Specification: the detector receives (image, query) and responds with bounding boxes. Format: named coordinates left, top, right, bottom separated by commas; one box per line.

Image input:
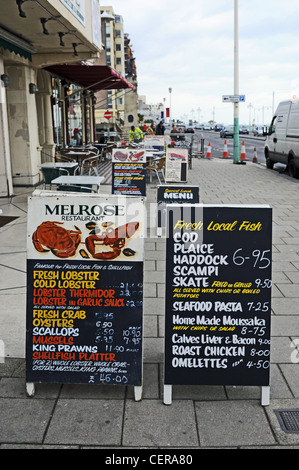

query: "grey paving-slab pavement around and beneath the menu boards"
left=0, top=158, right=299, bottom=454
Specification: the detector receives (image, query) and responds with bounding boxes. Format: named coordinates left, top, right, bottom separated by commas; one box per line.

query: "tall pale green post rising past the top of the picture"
left=234, top=0, right=239, bottom=163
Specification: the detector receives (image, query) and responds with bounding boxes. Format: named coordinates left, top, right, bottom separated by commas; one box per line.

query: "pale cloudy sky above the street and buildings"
left=100, top=0, right=299, bottom=125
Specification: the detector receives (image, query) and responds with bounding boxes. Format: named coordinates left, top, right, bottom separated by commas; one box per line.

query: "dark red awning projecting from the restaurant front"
left=44, top=64, right=136, bottom=92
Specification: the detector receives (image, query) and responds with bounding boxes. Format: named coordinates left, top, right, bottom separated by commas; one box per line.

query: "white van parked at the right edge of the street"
left=265, top=99, right=299, bottom=178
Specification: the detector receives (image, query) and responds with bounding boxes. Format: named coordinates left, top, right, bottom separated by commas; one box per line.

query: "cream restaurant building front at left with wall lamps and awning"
left=0, top=0, right=134, bottom=197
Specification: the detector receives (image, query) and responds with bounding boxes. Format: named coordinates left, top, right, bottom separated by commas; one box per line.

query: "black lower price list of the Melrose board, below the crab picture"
left=26, top=260, right=143, bottom=385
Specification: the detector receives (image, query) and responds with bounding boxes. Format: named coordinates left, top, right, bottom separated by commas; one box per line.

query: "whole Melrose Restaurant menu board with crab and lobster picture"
left=26, top=191, right=145, bottom=386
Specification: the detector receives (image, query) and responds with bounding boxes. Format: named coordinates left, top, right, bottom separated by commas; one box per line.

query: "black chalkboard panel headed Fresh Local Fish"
left=164, top=205, right=272, bottom=386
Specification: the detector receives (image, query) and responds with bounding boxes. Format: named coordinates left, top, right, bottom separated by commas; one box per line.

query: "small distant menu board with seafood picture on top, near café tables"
left=112, top=148, right=146, bottom=196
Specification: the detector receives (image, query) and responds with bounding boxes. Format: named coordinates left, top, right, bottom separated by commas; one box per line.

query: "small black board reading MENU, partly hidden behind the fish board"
left=157, top=184, right=199, bottom=227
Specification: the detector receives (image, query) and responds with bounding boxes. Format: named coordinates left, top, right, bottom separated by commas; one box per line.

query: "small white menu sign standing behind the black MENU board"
left=165, top=148, right=188, bottom=183
